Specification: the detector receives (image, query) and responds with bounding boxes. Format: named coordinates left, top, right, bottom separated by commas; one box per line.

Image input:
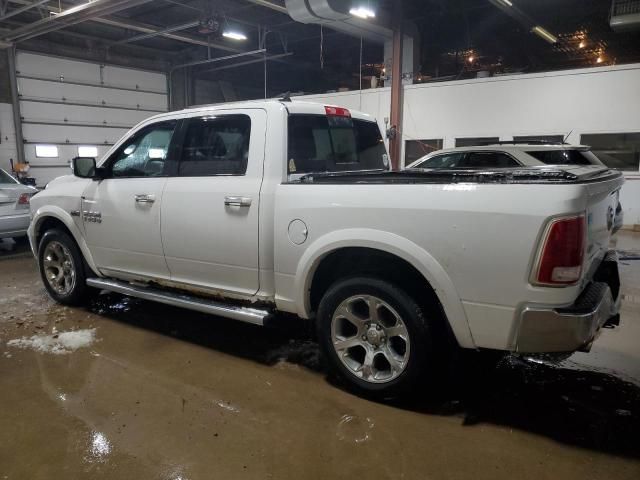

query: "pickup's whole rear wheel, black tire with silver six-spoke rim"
left=317, top=277, right=437, bottom=398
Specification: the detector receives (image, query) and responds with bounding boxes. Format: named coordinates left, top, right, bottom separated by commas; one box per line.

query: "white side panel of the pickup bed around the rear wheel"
left=274, top=180, right=600, bottom=349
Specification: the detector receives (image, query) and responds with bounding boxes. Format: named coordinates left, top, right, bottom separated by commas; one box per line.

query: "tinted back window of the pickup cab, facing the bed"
left=288, top=115, right=388, bottom=174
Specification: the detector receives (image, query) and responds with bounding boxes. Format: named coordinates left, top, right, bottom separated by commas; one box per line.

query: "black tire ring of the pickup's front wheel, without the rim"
left=38, top=229, right=93, bottom=305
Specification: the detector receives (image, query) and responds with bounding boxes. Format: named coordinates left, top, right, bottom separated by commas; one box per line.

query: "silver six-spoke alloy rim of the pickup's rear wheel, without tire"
left=331, top=295, right=410, bottom=383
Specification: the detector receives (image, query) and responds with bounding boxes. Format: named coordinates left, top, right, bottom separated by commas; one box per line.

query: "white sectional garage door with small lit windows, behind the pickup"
left=16, top=52, right=168, bottom=186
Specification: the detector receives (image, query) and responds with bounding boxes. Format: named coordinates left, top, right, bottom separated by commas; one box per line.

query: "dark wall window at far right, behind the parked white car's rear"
left=580, top=132, right=640, bottom=172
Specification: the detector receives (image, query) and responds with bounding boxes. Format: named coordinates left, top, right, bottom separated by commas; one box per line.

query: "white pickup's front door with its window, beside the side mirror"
left=82, top=120, right=178, bottom=279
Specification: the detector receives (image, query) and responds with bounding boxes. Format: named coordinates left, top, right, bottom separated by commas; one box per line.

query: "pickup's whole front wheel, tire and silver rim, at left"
left=38, top=230, right=89, bottom=305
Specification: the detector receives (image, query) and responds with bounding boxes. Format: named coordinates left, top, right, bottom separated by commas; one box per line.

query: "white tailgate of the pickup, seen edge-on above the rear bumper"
left=584, top=170, right=624, bottom=279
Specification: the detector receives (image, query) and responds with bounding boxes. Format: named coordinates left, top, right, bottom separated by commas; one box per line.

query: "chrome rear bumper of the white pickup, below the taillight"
left=516, top=251, right=620, bottom=353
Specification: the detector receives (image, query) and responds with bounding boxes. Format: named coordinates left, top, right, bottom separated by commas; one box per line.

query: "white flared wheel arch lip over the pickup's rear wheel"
left=295, top=229, right=475, bottom=348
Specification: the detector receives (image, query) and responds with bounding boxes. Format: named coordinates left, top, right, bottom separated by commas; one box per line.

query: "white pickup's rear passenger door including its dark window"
left=162, top=109, right=266, bottom=295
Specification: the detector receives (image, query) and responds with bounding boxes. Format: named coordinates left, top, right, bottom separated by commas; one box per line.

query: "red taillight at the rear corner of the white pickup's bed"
left=535, top=215, right=586, bottom=285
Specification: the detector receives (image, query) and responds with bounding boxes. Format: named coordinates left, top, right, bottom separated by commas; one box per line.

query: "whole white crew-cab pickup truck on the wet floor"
left=29, top=101, right=623, bottom=395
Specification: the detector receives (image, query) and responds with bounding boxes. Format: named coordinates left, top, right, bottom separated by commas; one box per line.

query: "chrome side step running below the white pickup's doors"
left=87, top=278, right=270, bottom=327
